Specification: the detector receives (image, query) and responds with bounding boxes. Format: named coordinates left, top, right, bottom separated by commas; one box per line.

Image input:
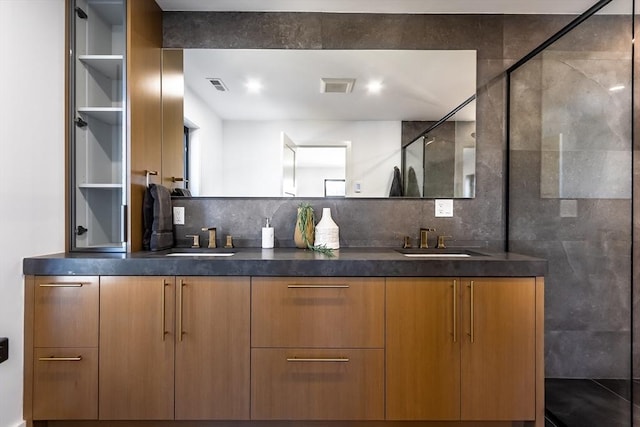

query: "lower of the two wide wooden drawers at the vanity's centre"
left=251, top=348, right=384, bottom=420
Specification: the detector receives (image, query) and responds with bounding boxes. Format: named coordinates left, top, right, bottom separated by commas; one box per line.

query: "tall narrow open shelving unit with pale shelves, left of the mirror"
left=69, top=0, right=127, bottom=251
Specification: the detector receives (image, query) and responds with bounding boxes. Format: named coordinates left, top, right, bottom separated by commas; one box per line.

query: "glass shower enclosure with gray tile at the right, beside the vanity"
left=507, top=0, right=640, bottom=427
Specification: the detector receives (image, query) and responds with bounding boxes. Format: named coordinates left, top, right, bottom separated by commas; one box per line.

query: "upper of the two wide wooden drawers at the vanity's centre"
left=251, top=277, right=384, bottom=348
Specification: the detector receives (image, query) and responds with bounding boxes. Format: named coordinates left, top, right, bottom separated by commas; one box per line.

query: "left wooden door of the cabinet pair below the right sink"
left=386, top=278, right=460, bottom=420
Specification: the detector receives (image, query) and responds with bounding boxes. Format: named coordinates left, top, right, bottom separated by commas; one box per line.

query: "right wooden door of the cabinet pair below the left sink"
left=175, top=277, right=251, bottom=420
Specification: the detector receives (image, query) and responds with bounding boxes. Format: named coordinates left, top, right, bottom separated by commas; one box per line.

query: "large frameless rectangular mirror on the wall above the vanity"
left=184, top=49, right=476, bottom=198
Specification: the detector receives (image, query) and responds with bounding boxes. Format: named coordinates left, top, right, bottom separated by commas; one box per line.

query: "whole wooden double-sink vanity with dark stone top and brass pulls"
left=24, top=248, right=547, bottom=427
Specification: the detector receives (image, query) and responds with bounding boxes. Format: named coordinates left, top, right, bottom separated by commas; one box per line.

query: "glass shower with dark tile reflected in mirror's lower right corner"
left=402, top=95, right=476, bottom=198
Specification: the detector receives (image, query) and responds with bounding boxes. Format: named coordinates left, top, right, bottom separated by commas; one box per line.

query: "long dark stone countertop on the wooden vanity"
left=23, top=248, right=547, bottom=277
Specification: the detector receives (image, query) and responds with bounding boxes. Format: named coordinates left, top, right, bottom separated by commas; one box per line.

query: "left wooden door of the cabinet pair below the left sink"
left=99, top=276, right=175, bottom=420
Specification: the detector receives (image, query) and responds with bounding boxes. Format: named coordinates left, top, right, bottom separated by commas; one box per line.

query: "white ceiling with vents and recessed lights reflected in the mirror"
left=184, top=49, right=476, bottom=121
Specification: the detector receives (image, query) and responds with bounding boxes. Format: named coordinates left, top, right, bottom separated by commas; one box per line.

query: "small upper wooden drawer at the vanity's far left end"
left=33, top=276, right=100, bottom=347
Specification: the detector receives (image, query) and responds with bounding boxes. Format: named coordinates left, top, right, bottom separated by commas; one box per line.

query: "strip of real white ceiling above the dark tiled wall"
left=156, top=0, right=630, bottom=14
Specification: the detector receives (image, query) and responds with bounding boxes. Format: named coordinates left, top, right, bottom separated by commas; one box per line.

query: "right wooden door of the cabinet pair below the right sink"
left=461, top=278, right=536, bottom=420
